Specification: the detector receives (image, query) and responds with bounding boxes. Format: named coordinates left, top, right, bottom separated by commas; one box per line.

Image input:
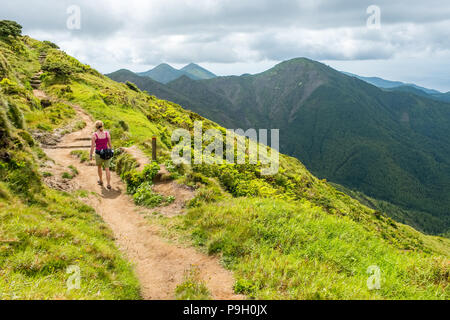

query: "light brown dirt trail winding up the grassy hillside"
left=44, top=105, right=244, bottom=300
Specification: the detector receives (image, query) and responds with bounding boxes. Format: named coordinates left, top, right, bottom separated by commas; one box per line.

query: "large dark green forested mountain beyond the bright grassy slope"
left=112, top=59, right=450, bottom=234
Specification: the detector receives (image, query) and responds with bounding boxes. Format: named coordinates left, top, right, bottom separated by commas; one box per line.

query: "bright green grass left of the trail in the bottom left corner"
left=0, top=190, right=140, bottom=300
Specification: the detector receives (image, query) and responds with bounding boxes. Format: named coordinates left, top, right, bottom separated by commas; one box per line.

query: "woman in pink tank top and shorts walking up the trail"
left=90, top=121, right=112, bottom=190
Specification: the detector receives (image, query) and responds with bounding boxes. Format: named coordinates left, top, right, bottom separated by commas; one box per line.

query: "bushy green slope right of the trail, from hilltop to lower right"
left=0, top=28, right=450, bottom=299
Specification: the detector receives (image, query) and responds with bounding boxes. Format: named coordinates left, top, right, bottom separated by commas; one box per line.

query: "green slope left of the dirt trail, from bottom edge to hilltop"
left=0, top=33, right=140, bottom=300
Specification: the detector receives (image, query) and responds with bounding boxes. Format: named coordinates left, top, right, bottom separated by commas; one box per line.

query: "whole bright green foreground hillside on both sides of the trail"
left=0, top=26, right=450, bottom=300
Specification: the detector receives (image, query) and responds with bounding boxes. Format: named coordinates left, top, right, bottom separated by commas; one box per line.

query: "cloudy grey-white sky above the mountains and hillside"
left=0, top=0, right=450, bottom=91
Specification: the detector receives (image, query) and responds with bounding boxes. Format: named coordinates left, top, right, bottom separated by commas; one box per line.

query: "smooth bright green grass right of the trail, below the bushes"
left=171, top=198, right=450, bottom=299
